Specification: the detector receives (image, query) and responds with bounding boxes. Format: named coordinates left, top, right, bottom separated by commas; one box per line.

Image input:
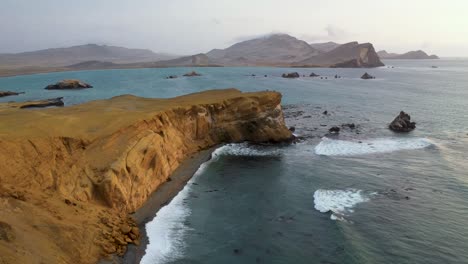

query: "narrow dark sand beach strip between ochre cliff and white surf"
left=99, top=146, right=218, bottom=264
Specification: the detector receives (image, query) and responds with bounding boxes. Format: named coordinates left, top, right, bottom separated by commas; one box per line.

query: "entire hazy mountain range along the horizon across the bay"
left=0, top=34, right=438, bottom=76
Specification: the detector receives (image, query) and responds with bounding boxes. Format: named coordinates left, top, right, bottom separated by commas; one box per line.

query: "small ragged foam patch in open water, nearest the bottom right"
left=314, top=189, right=372, bottom=221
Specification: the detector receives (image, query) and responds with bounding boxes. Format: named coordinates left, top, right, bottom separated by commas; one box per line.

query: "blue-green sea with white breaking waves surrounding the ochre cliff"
left=0, top=60, right=468, bottom=264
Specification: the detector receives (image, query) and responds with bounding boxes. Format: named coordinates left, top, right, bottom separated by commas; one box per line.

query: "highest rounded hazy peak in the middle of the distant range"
left=206, top=34, right=320, bottom=66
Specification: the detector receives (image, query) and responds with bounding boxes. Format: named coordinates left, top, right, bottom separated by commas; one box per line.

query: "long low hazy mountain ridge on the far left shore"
left=0, top=44, right=175, bottom=68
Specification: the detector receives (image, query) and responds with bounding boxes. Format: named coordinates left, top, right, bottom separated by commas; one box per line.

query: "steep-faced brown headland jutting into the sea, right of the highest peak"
left=295, top=42, right=384, bottom=68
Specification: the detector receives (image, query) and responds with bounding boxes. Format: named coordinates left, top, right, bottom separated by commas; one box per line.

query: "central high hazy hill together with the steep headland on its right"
left=156, top=34, right=383, bottom=67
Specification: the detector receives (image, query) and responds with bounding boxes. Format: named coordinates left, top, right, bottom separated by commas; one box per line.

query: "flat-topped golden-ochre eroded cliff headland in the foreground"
left=0, top=89, right=291, bottom=264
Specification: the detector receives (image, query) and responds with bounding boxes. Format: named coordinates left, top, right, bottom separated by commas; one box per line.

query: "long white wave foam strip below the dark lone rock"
left=315, top=137, right=433, bottom=156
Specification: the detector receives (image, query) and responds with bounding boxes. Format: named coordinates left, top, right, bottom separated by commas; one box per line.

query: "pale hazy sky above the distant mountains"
left=0, top=0, right=468, bottom=57
